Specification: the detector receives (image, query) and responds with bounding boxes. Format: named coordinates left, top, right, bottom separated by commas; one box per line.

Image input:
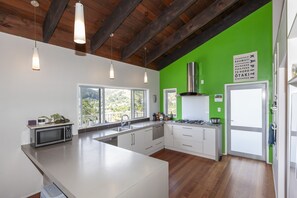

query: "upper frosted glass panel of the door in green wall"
left=231, top=89, right=262, bottom=128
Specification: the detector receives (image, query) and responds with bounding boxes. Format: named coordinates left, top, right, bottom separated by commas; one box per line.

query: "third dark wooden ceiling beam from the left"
left=122, top=0, right=197, bottom=60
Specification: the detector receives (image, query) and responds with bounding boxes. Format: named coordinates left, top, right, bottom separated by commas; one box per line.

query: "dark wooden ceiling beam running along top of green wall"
left=157, top=0, right=271, bottom=70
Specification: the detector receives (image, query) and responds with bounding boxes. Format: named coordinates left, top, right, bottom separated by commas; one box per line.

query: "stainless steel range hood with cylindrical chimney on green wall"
left=179, top=62, right=205, bottom=96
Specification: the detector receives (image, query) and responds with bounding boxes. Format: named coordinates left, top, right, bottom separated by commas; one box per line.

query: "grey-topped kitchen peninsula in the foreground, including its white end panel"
left=22, top=122, right=168, bottom=198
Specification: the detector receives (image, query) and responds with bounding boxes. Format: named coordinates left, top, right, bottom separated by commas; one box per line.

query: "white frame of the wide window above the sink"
left=77, top=84, right=150, bottom=129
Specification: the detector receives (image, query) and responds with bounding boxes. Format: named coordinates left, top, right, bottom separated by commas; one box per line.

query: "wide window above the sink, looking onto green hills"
left=78, top=85, right=147, bottom=127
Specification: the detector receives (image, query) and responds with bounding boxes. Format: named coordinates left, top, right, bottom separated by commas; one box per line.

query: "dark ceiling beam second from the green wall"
left=147, top=0, right=239, bottom=64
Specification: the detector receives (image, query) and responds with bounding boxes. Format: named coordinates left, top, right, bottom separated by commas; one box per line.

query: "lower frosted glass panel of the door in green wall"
left=231, top=130, right=262, bottom=156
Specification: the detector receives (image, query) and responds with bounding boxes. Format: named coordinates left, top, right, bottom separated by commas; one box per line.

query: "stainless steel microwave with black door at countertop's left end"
left=30, top=124, right=72, bottom=147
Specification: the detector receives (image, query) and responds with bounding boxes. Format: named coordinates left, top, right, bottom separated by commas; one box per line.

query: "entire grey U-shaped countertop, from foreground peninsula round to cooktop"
left=22, top=121, right=217, bottom=198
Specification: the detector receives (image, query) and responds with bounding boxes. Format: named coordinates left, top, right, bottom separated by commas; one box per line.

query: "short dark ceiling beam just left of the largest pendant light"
left=43, top=0, right=69, bottom=43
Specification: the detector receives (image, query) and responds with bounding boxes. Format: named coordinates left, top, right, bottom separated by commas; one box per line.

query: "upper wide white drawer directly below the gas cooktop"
left=173, top=126, right=203, bottom=141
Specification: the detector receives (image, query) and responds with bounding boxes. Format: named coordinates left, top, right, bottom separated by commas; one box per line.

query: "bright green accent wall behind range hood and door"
left=160, top=3, right=272, bottom=162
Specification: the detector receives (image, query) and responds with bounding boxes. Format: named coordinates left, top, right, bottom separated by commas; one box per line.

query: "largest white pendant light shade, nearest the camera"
left=74, top=1, right=86, bottom=44
